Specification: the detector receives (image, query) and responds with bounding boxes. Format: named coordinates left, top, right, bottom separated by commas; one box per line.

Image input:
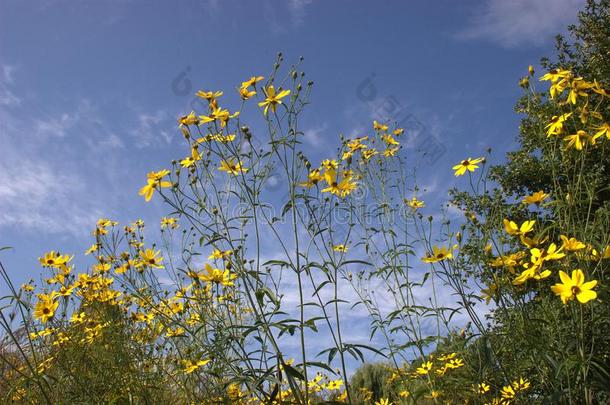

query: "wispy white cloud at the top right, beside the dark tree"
left=457, top=0, right=584, bottom=47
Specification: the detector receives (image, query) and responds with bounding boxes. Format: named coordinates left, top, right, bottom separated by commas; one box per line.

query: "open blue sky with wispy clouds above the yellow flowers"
left=0, top=0, right=583, bottom=364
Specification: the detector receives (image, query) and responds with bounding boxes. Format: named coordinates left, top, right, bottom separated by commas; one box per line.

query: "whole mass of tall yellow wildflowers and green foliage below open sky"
left=0, top=0, right=610, bottom=405
